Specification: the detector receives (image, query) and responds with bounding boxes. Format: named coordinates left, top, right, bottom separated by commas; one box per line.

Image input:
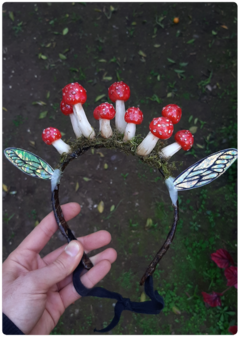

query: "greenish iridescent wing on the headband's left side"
left=4, top=147, right=54, bottom=180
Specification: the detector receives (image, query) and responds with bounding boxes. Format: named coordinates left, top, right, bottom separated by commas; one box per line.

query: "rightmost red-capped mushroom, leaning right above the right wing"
left=159, top=130, right=194, bottom=158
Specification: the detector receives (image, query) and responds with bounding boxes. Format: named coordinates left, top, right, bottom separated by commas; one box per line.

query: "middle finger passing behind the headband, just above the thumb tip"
left=43, top=230, right=112, bottom=265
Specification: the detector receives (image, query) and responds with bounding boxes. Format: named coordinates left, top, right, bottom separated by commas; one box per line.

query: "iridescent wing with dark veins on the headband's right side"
left=173, top=149, right=239, bottom=191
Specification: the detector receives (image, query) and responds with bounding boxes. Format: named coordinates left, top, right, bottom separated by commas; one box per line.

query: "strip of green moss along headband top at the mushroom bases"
left=59, top=130, right=175, bottom=179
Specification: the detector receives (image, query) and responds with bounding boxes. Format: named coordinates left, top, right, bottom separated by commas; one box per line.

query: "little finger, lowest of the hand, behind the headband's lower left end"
left=60, top=260, right=111, bottom=308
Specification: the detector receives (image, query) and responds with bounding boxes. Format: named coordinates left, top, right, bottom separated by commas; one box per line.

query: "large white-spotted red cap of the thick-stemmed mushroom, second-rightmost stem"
left=149, top=117, right=173, bottom=139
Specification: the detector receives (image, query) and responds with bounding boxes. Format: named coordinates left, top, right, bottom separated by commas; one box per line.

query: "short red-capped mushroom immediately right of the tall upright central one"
left=123, top=107, right=143, bottom=142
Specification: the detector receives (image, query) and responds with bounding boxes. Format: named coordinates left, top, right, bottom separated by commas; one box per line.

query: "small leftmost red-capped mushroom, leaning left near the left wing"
left=42, top=127, right=71, bottom=154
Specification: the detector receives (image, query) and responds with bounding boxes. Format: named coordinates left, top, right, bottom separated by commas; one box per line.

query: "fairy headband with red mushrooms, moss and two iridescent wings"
left=4, top=82, right=239, bottom=330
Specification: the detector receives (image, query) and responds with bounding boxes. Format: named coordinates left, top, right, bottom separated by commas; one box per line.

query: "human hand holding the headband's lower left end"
left=0, top=203, right=117, bottom=336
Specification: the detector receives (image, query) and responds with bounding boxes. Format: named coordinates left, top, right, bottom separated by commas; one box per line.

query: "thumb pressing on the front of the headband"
left=31, top=240, right=83, bottom=290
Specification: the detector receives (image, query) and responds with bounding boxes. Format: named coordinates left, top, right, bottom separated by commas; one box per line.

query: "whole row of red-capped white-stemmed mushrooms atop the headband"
left=42, top=81, right=194, bottom=159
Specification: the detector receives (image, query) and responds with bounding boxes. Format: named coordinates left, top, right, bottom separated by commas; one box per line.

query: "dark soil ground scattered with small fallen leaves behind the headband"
left=0, top=1, right=239, bottom=335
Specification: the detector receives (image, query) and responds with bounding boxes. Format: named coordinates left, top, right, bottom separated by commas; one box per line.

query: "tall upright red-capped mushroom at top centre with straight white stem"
left=108, top=81, right=130, bottom=133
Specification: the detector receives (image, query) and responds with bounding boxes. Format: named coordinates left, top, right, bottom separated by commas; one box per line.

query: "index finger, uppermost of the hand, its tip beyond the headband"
left=17, top=202, right=81, bottom=254
